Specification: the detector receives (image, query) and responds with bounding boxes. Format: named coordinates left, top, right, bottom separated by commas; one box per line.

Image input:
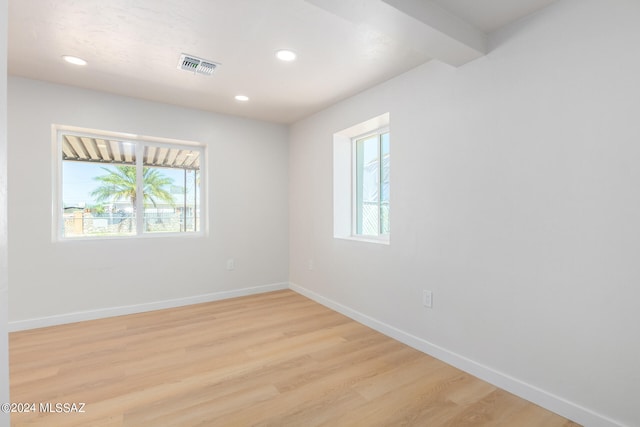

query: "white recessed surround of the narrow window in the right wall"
left=333, top=113, right=392, bottom=245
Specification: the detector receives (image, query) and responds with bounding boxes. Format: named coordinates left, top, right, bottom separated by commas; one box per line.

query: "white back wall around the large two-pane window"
left=8, top=76, right=288, bottom=329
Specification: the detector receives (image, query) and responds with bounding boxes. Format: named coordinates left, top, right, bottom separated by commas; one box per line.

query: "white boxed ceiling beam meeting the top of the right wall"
left=306, top=0, right=487, bottom=67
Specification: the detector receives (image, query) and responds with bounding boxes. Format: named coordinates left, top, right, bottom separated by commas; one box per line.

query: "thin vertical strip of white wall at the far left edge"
left=0, top=0, right=9, bottom=427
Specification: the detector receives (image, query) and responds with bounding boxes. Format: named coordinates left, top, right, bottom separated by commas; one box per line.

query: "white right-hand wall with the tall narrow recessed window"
left=289, top=0, right=640, bottom=426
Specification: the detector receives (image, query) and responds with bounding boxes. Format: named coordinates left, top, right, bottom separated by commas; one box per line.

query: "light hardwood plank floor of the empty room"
left=9, top=291, right=577, bottom=427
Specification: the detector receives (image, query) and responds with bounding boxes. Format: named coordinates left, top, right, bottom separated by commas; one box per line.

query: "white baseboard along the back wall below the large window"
left=9, top=283, right=289, bottom=332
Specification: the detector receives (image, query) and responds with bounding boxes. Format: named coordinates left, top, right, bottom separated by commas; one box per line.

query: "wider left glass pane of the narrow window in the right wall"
left=356, top=135, right=380, bottom=236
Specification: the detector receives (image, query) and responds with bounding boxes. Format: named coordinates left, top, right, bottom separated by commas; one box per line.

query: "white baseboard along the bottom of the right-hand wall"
left=289, top=283, right=624, bottom=427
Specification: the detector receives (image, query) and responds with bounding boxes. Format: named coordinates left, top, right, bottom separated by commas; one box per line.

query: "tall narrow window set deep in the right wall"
left=353, top=130, right=391, bottom=237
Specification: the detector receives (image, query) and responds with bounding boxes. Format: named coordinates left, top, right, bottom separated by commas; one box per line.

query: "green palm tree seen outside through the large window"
left=91, top=166, right=175, bottom=212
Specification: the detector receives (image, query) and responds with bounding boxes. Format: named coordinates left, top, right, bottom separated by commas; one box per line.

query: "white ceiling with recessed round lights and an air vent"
left=8, top=0, right=554, bottom=123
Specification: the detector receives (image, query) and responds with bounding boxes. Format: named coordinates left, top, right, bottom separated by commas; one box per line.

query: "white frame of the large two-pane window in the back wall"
left=51, top=124, right=208, bottom=242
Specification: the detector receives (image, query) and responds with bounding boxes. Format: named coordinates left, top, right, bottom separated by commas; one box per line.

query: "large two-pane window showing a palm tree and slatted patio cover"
left=54, top=127, right=204, bottom=239
